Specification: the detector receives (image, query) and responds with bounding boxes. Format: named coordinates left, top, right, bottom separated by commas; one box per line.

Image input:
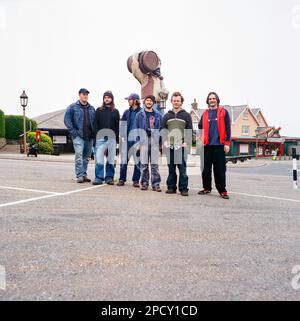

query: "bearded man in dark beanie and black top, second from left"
left=93, top=91, right=120, bottom=185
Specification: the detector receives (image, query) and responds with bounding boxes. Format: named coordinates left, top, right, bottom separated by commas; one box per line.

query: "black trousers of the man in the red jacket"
left=202, top=145, right=226, bottom=193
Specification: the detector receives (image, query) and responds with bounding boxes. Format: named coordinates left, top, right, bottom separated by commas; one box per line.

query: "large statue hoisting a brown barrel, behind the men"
left=127, top=51, right=169, bottom=109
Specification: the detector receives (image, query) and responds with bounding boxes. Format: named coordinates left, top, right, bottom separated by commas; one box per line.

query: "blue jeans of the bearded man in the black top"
left=95, top=138, right=117, bottom=182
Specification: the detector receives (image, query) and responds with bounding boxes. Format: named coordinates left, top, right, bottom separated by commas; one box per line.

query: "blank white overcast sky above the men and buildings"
left=0, top=0, right=300, bottom=136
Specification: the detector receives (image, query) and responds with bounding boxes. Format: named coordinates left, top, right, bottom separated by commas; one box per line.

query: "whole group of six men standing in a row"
left=64, top=88, right=230, bottom=198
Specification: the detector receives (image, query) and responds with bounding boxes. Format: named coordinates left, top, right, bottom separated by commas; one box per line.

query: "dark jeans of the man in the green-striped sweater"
left=167, top=148, right=189, bottom=192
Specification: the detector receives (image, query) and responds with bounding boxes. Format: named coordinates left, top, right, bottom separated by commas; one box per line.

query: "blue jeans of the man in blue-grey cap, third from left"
left=120, top=142, right=141, bottom=182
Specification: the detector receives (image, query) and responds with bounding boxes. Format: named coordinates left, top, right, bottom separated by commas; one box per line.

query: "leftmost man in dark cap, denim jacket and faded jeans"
left=64, top=88, right=95, bottom=183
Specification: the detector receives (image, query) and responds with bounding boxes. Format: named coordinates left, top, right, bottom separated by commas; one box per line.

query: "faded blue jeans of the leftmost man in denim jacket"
left=73, top=136, right=93, bottom=178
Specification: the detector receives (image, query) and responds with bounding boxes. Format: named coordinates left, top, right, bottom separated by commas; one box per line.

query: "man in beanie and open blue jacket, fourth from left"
left=136, top=95, right=162, bottom=192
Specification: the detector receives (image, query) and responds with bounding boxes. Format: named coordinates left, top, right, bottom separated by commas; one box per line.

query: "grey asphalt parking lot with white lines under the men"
left=0, top=159, right=300, bottom=300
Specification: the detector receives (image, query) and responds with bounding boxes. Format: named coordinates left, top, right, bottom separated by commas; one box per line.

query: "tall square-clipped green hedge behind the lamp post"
left=5, top=115, right=37, bottom=139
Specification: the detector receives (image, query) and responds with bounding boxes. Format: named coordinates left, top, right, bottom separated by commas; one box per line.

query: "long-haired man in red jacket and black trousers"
left=198, top=92, right=231, bottom=199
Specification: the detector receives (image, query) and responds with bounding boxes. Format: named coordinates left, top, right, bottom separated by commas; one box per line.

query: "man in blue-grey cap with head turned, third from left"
left=117, top=93, right=142, bottom=187
